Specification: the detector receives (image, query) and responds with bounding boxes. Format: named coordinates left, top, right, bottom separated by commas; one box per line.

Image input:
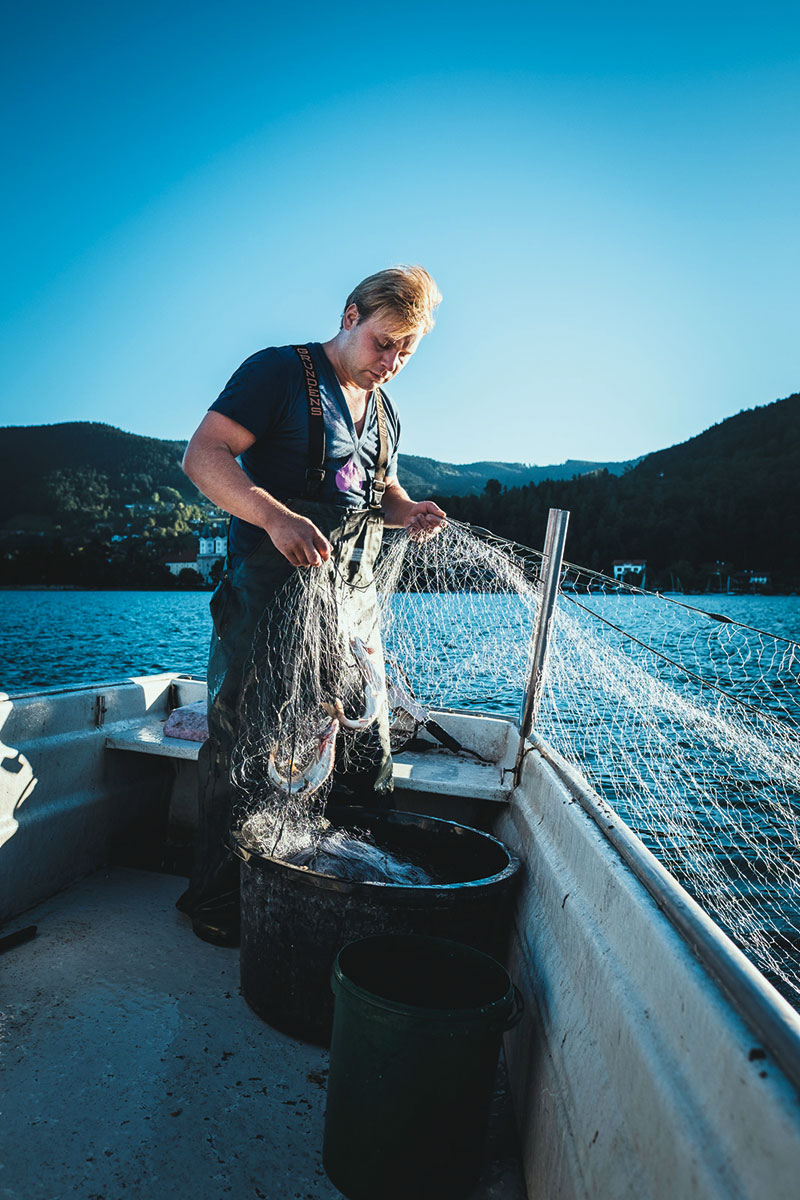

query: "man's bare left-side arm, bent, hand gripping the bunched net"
left=184, top=413, right=331, bottom=566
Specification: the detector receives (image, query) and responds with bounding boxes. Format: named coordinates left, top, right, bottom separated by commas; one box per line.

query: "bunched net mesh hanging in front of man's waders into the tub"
left=231, top=544, right=383, bottom=860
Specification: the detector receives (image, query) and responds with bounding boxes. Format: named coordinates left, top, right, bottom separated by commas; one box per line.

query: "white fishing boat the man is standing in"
left=0, top=673, right=800, bottom=1200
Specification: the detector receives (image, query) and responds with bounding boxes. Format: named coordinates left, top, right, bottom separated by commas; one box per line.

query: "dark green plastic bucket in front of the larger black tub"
left=323, top=935, right=519, bottom=1200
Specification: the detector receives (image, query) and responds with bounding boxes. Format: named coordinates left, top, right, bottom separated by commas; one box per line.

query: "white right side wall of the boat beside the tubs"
left=497, top=751, right=800, bottom=1200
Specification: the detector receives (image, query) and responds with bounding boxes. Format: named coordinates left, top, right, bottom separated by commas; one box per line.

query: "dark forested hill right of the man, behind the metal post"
left=443, top=394, right=800, bottom=588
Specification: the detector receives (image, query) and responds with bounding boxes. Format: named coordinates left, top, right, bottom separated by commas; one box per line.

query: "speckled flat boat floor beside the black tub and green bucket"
left=0, top=869, right=525, bottom=1200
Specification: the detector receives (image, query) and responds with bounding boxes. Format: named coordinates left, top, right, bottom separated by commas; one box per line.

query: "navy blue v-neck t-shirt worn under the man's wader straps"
left=210, top=342, right=399, bottom=559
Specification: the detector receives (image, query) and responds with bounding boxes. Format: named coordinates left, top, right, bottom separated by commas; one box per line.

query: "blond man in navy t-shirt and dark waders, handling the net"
left=179, top=266, right=445, bottom=944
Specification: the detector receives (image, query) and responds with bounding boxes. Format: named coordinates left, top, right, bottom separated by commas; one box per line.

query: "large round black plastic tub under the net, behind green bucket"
left=233, top=808, right=519, bottom=1045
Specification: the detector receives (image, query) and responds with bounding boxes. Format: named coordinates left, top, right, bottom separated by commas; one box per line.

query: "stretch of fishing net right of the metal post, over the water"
left=537, top=566, right=800, bottom=1003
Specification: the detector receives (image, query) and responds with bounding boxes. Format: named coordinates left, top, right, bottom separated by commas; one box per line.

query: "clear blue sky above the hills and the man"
left=0, top=0, right=800, bottom=463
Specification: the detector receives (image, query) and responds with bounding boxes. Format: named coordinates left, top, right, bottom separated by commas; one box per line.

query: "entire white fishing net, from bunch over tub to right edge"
left=226, top=522, right=800, bottom=1002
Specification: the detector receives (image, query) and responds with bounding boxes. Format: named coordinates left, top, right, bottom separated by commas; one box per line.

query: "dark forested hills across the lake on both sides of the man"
left=0, top=395, right=800, bottom=590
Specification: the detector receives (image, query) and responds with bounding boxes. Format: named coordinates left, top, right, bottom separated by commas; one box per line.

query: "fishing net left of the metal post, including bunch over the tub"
left=231, top=524, right=537, bottom=877
